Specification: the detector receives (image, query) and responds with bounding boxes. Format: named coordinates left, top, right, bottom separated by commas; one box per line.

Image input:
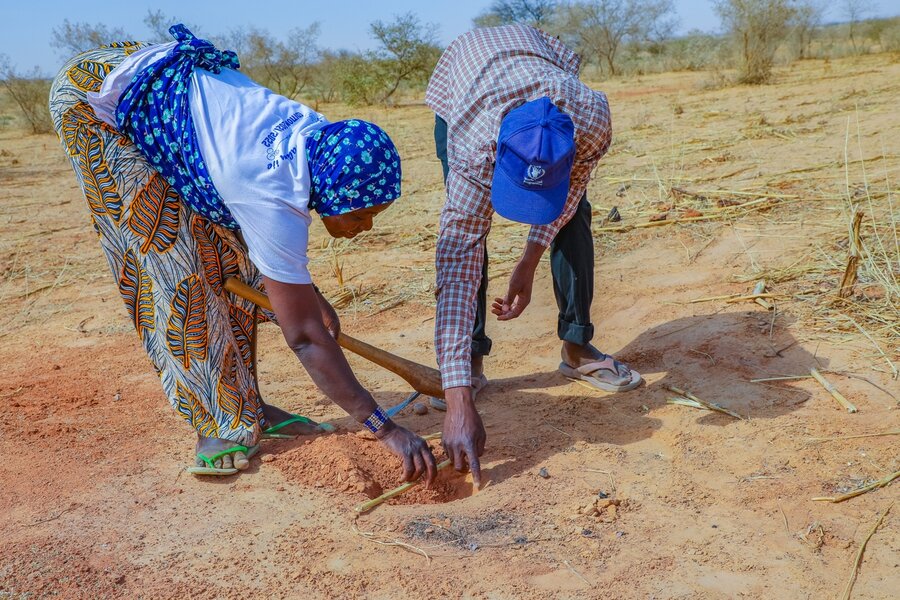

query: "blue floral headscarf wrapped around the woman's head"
left=306, top=119, right=400, bottom=217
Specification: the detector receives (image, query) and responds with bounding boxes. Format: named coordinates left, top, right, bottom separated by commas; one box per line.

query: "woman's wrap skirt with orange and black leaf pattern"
left=50, top=42, right=267, bottom=446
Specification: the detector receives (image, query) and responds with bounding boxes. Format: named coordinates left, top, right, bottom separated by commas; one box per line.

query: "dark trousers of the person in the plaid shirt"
left=434, top=115, right=594, bottom=356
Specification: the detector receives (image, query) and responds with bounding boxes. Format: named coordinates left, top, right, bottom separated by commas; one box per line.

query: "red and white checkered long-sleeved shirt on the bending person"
left=425, top=25, right=612, bottom=389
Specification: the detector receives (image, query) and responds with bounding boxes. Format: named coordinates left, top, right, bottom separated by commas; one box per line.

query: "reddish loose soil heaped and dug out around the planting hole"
left=273, top=433, right=471, bottom=504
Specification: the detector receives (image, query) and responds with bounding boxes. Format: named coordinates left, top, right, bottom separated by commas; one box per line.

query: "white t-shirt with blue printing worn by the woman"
left=88, top=42, right=328, bottom=283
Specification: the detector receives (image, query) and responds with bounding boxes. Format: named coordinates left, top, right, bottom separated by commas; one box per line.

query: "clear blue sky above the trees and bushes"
left=0, top=0, right=900, bottom=74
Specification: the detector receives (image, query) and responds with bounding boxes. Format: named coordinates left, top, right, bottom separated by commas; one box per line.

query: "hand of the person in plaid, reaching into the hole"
left=441, top=386, right=487, bottom=489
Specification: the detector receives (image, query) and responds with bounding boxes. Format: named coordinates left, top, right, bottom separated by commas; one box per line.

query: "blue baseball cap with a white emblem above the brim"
left=491, top=98, right=575, bottom=225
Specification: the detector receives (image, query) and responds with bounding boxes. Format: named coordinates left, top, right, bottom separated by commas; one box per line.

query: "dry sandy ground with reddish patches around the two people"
left=0, top=56, right=900, bottom=599
